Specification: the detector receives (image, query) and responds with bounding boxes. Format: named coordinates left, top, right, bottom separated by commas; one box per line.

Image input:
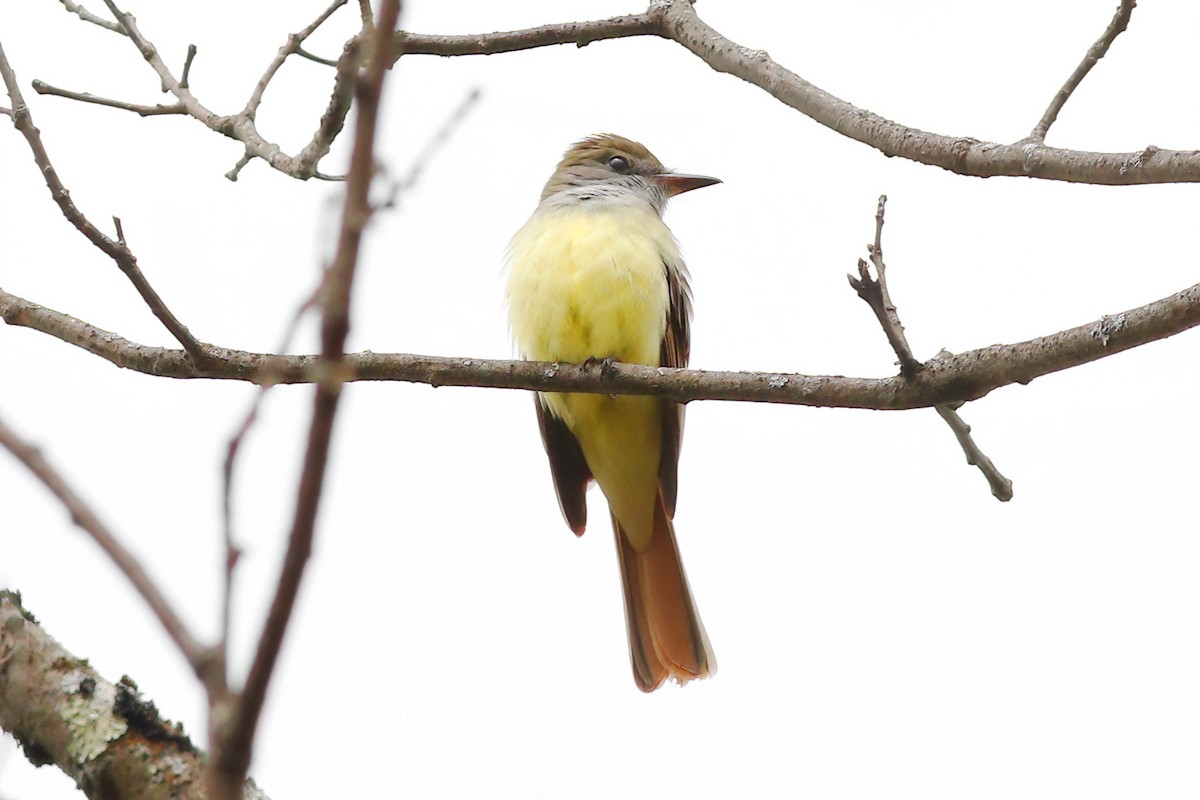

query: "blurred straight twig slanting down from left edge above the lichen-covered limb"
left=0, top=421, right=212, bottom=685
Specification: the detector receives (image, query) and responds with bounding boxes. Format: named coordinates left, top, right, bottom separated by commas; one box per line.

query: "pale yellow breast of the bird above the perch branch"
left=508, top=205, right=679, bottom=365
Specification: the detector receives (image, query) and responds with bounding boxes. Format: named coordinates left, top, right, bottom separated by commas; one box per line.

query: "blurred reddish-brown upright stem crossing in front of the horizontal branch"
left=210, top=0, right=400, bottom=798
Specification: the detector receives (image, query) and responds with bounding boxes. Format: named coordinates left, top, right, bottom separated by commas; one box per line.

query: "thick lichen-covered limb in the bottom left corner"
left=0, top=590, right=265, bottom=800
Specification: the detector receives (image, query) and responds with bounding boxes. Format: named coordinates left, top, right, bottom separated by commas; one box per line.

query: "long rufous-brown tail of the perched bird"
left=612, top=495, right=716, bottom=692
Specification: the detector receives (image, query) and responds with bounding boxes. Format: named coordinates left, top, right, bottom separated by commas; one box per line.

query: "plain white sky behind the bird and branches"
left=0, top=0, right=1200, bottom=800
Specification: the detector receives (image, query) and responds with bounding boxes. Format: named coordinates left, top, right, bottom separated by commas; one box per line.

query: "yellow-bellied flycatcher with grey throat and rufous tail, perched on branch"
left=508, top=134, right=720, bottom=692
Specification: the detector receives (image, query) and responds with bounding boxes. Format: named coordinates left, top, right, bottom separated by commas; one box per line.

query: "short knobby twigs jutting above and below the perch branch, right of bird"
left=846, top=196, right=1013, bottom=503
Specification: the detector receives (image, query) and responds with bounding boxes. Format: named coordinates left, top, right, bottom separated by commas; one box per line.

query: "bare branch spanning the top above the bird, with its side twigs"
left=37, top=0, right=1200, bottom=186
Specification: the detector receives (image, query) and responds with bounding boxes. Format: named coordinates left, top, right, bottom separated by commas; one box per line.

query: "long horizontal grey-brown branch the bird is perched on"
left=0, top=283, right=1200, bottom=410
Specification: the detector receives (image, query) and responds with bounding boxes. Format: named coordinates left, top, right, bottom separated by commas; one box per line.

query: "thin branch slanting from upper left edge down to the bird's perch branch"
left=0, top=47, right=208, bottom=365
